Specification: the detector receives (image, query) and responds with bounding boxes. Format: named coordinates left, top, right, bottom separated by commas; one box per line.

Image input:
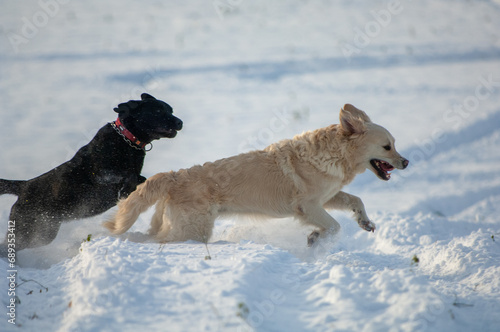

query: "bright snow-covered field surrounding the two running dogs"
left=0, top=0, right=500, bottom=331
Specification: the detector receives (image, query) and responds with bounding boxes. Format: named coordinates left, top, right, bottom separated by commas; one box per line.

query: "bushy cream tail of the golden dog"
left=103, top=172, right=175, bottom=234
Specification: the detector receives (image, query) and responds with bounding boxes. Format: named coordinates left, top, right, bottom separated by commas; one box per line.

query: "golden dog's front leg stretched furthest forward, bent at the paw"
left=324, top=191, right=376, bottom=232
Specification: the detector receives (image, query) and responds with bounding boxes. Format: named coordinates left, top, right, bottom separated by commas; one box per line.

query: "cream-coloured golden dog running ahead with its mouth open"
left=105, top=104, right=408, bottom=245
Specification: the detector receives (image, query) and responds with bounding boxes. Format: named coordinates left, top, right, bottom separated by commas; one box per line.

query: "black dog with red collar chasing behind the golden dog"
left=0, top=93, right=182, bottom=256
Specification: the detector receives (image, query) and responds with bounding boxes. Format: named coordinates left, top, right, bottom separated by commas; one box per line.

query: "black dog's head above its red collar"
left=114, top=93, right=182, bottom=142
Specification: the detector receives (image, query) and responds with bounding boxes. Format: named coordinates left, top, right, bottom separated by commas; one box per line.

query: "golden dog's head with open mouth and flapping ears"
left=340, top=104, right=409, bottom=181
